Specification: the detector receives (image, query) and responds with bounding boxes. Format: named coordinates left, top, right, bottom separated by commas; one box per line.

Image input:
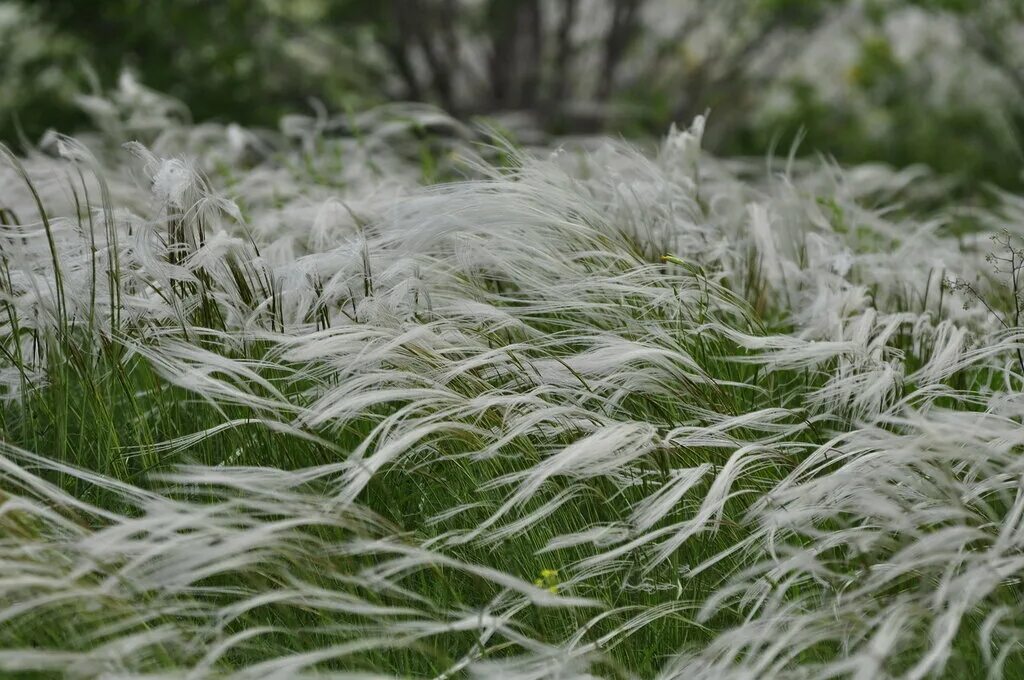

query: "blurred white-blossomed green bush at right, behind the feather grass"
left=751, top=0, right=1024, bottom=186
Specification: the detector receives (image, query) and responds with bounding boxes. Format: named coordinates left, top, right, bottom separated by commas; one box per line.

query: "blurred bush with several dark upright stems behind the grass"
left=315, top=0, right=643, bottom=126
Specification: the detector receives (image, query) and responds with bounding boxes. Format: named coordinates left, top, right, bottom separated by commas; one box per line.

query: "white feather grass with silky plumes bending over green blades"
left=0, top=86, right=1024, bottom=680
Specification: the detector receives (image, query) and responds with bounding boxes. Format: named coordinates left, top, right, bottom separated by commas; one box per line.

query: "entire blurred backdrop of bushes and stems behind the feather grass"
left=0, top=0, right=1024, bottom=196
